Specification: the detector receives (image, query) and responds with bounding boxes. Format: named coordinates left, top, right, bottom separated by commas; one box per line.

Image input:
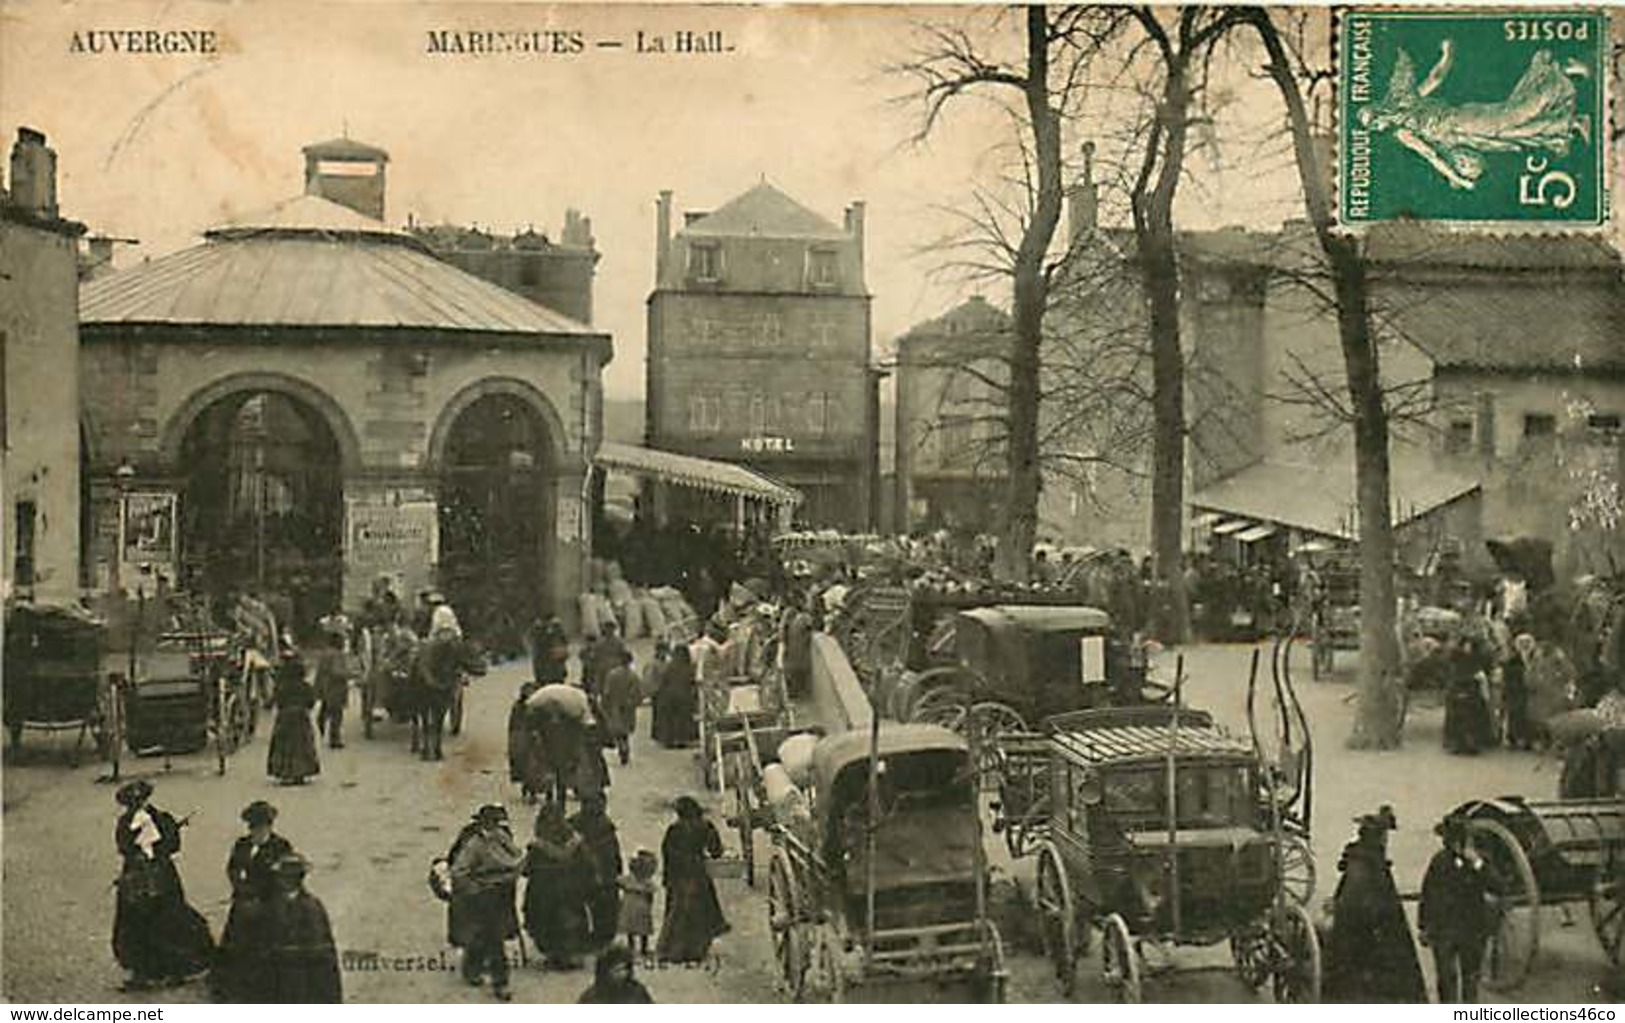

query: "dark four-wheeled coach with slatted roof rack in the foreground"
left=1037, top=706, right=1321, bottom=1002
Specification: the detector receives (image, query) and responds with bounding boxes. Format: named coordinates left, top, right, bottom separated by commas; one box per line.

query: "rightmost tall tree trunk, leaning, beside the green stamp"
left=1248, top=8, right=1404, bottom=749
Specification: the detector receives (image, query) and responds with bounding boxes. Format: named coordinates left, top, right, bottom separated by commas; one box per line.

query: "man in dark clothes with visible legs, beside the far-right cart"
left=1419, top=814, right=1495, bottom=1005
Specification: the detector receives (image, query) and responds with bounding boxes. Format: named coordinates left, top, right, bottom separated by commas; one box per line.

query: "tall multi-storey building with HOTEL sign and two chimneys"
left=645, top=182, right=879, bottom=529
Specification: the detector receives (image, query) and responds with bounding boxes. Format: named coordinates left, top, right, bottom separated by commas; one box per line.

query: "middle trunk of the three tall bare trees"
left=1133, top=55, right=1190, bottom=643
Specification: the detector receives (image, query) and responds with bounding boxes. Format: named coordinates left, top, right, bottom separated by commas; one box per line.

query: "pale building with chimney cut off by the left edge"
left=0, top=128, right=85, bottom=602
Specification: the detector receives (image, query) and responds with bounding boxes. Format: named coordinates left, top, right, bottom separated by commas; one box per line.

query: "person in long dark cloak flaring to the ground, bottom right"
left=1323, top=805, right=1427, bottom=1004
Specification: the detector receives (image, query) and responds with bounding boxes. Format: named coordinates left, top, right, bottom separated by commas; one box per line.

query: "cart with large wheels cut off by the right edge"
left=1454, top=797, right=1625, bottom=991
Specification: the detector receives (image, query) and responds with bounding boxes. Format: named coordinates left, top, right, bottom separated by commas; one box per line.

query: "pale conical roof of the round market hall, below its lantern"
left=80, top=195, right=608, bottom=341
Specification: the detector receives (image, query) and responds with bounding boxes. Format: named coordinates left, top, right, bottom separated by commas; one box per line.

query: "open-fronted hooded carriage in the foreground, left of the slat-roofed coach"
left=769, top=723, right=1004, bottom=1002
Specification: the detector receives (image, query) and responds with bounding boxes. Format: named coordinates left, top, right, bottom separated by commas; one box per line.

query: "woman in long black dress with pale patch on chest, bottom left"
left=112, top=781, right=215, bottom=991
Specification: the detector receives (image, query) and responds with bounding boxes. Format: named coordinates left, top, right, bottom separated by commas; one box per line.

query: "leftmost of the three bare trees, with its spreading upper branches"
left=892, top=6, right=1120, bottom=580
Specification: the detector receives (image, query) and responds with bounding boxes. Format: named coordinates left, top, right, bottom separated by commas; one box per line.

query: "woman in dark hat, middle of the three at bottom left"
left=210, top=799, right=294, bottom=1002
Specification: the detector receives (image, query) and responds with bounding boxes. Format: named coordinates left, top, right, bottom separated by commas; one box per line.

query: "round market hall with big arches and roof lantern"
left=80, top=140, right=613, bottom=643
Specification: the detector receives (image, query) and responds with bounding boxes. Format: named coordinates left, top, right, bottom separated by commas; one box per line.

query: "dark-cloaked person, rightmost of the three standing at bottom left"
left=265, top=853, right=345, bottom=1005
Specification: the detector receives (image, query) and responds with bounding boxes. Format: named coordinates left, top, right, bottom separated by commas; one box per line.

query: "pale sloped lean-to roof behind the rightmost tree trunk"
left=1191, top=458, right=1480, bottom=539
